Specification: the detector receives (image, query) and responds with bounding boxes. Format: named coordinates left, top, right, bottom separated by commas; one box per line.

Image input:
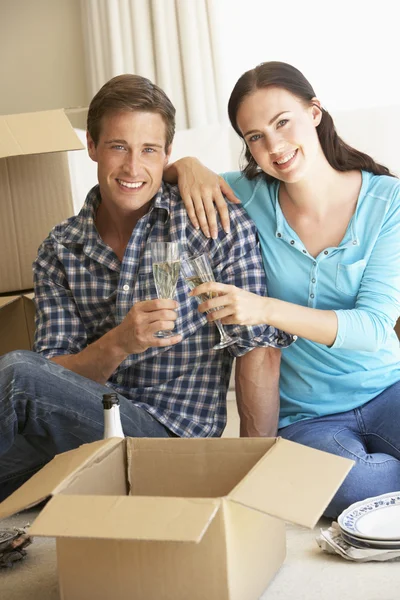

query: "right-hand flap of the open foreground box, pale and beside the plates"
left=228, top=438, right=354, bottom=528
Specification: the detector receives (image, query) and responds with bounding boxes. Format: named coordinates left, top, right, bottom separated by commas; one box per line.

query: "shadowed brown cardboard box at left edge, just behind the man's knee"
left=0, top=294, right=35, bottom=356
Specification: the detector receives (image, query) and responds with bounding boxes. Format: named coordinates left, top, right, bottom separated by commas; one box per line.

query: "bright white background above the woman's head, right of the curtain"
left=211, top=0, right=400, bottom=110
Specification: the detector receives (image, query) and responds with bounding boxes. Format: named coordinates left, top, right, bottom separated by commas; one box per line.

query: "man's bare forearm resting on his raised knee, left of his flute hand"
left=51, top=328, right=128, bottom=383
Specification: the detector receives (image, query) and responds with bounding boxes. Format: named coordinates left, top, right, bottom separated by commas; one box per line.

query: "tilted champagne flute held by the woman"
left=182, top=254, right=237, bottom=350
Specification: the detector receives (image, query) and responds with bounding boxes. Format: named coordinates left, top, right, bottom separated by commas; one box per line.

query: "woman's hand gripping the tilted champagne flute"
left=189, top=281, right=269, bottom=325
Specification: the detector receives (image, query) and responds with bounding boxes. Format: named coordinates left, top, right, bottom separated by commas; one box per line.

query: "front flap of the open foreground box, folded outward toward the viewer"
left=30, top=494, right=220, bottom=542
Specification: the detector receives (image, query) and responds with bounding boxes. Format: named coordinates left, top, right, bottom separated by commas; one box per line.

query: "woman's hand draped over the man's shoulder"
left=164, top=157, right=240, bottom=239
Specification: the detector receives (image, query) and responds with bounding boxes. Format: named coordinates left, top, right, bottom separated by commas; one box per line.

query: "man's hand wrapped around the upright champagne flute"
left=115, top=299, right=182, bottom=355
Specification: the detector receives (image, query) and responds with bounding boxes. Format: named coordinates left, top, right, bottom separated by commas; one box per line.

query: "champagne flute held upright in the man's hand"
left=150, top=242, right=181, bottom=338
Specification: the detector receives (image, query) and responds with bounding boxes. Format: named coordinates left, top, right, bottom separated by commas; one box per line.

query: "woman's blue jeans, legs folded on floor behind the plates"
left=279, top=382, right=400, bottom=518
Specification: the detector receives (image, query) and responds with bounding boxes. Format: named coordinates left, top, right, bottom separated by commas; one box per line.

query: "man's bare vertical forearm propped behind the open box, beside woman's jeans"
left=235, top=347, right=281, bottom=437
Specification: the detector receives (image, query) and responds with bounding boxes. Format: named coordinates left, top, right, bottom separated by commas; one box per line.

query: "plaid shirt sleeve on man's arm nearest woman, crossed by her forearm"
left=203, top=199, right=295, bottom=356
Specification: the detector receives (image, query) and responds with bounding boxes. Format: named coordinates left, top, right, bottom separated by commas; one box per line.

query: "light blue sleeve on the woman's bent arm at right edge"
left=331, top=186, right=400, bottom=352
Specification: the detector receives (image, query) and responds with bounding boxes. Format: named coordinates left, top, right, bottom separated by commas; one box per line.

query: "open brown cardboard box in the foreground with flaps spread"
left=0, top=438, right=353, bottom=600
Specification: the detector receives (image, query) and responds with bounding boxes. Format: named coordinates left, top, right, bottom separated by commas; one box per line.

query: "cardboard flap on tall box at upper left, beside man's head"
left=0, top=109, right=83, bottom=158
